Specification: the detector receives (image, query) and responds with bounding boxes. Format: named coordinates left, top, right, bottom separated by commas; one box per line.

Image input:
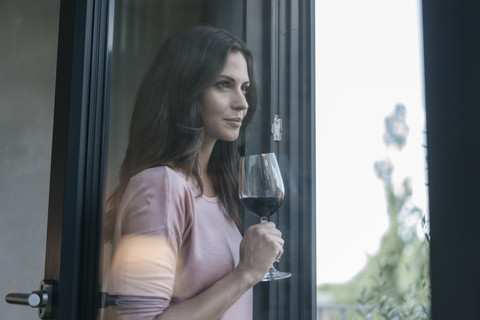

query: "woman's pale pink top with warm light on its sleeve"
left=108, top=166, right=253, bottom=320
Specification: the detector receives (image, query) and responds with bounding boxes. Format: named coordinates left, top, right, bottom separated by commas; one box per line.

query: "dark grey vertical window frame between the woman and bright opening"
left=244, top=0, right=316, bottom=320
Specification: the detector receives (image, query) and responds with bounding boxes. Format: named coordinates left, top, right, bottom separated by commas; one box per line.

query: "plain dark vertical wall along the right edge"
left=423, top=0, right=480, bottom=320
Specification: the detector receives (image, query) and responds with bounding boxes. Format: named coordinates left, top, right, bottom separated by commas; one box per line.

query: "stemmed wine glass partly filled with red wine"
left=239, top=152, right=292, bottom=281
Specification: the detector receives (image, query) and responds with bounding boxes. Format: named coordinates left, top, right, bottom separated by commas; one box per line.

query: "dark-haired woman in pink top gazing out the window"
left=107, top=27, right=283, bottom=320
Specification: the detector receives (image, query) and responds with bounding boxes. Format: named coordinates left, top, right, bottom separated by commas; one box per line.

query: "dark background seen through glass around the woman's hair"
left=99, top=0, right=243, bottom=319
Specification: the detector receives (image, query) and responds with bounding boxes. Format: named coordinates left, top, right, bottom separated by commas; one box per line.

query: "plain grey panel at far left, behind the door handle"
left=0, top=0, right=60, bottom=320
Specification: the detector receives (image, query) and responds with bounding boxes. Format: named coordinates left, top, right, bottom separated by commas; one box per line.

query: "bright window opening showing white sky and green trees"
left=316, top=0, right=430, bottom=319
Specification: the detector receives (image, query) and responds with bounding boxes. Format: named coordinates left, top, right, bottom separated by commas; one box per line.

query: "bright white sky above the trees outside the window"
left=315, top=0, right=428, bottom=284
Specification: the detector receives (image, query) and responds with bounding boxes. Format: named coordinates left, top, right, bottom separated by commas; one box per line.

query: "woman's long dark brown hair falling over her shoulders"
left=104, top=26, right=257, bottom=241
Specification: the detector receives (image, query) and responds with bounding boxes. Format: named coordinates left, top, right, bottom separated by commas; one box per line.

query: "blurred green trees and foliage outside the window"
left=318, top=105, right=431, bottom=320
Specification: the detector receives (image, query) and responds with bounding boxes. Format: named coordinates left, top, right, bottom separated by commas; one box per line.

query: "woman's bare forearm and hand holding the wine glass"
left=156, top=222, right=283, bottom=320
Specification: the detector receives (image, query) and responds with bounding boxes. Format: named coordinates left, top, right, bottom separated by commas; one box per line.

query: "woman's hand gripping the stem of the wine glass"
left=237, top=222, right=284, bottom=285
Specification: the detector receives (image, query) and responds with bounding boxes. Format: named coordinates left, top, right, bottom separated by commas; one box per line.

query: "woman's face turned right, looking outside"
left=202, top=51, right=250, bottom=142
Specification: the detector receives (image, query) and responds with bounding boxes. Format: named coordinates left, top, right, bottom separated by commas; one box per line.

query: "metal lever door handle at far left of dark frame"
left=5, top=280, right=55, bottom=319
